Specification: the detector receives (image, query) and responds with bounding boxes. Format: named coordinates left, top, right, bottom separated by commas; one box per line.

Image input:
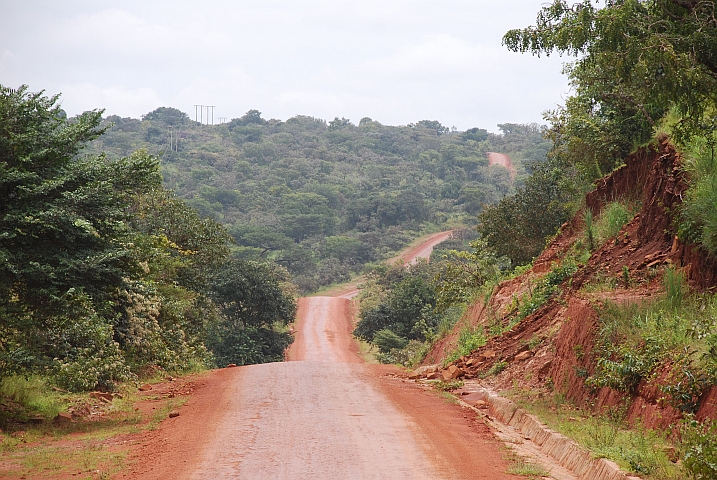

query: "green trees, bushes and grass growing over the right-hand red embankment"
left=356, top=0, right=717, bottom=479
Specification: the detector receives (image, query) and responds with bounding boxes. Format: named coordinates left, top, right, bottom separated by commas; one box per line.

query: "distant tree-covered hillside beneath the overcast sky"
left=92, top=108, right=549, bottom=292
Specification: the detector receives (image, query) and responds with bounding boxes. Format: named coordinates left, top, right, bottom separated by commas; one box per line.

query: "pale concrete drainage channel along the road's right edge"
left=455, top=383, right=640, bottom=480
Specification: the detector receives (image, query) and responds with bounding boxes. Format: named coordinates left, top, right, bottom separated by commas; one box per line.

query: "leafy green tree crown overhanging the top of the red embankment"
left=503, top=0, right=717, bottom=139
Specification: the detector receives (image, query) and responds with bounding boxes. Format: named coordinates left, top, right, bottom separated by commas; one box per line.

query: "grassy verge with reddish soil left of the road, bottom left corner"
left=0, top=377, right=199, bottom=480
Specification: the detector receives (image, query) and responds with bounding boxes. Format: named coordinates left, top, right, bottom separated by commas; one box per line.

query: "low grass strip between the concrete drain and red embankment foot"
left=514, top=392, right=686, bottom=480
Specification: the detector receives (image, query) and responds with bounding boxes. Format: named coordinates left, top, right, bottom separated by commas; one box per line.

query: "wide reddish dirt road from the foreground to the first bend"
left=130, top=231, right=517, bottom=480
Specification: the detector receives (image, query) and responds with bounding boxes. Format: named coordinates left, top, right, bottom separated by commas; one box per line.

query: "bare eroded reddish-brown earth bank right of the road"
left=426, top=139, right=717, bottom=428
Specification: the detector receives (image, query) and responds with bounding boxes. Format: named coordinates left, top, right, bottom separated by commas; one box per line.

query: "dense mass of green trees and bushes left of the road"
left=0, top=87, right=295, bottom=391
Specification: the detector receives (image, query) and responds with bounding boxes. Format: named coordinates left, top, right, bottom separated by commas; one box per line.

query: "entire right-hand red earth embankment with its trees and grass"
left=374, top=0, right=717, bottom=479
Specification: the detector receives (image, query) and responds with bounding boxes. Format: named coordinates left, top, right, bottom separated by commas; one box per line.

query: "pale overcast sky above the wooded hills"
left=0, top=0, right=568, bottom=132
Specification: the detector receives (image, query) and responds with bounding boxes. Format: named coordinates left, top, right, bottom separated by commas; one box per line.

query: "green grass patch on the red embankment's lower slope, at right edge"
left=586, top=284, right=717, bottom=413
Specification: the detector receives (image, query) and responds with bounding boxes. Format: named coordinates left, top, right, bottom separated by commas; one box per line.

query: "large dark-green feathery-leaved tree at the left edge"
left=0, top=86, right=161, bottom=321
